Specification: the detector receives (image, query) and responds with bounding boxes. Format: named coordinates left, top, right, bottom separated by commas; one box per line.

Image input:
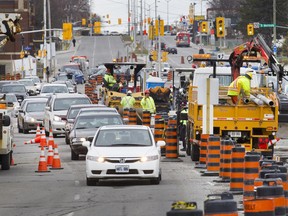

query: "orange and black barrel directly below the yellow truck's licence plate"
left=230, top=144, right=245, bottom=191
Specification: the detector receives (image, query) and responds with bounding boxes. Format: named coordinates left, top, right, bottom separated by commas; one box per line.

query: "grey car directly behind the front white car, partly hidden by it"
left=69, top=112, right=123, bottom=160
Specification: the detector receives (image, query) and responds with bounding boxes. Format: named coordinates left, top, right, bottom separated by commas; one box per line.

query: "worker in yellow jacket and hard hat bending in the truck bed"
left=227, top=68, right=253, bottom=104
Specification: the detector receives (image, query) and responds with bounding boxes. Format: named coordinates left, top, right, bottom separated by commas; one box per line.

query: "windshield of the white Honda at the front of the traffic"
left=94, top=128, right=152, bottom=147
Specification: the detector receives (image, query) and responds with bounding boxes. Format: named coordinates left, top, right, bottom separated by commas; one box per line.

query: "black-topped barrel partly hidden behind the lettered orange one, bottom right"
left=256, top=182, right=286, bottom=216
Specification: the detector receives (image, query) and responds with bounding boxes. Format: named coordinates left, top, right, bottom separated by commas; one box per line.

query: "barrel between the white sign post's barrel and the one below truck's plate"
left=219, top=139, right=234, bottom=181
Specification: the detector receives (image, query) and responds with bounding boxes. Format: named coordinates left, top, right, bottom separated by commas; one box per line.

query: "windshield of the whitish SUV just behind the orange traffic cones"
left=54, top=98, right=90, bottom=111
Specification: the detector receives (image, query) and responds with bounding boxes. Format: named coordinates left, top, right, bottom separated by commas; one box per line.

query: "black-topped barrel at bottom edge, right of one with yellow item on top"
left=204, top=192, right=238, bottom=216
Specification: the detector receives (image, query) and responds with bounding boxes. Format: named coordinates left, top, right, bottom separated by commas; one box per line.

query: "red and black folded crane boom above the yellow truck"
left=229, top=34, right=284, bottom=92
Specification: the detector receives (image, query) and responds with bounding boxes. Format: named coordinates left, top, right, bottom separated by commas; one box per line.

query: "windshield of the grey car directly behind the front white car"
left=75, top=115, right=123, bottom=129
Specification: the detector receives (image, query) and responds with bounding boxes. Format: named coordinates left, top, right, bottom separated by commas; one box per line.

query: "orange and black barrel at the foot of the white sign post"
left=206, top=135, right=220, bottom=172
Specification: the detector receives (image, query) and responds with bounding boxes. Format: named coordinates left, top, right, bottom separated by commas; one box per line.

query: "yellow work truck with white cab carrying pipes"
left=187, top=59, right=278, bottom=161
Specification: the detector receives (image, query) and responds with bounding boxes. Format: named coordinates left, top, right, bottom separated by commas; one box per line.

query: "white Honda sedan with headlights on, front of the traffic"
left=82, top=125, right=165, bottom=186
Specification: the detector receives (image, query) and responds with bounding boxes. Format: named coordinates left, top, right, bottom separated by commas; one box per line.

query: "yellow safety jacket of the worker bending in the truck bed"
left=227, top=76, right=250, bottom=97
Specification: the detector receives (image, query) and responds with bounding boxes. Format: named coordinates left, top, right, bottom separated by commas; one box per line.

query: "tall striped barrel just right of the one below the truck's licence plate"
left=243, top=152, right=260, bottom=200
